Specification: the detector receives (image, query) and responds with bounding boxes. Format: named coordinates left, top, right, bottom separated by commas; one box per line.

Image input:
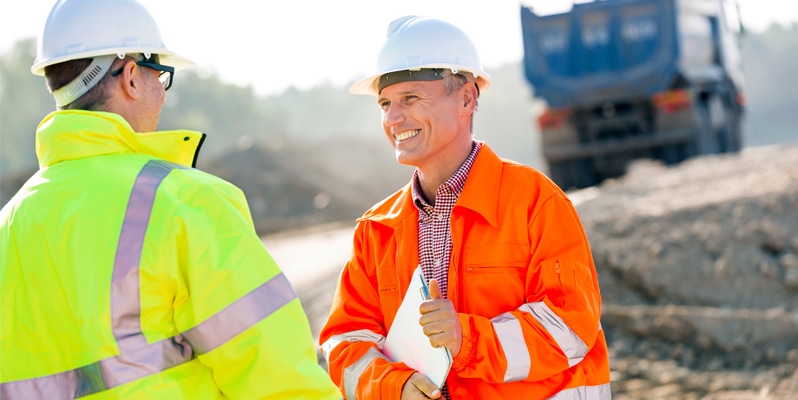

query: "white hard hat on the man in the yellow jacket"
left=31, top=0, right=194, bottom=75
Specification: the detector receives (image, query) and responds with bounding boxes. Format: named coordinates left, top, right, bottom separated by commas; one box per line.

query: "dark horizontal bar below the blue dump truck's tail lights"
left=543, top=129, right=695, bottom=162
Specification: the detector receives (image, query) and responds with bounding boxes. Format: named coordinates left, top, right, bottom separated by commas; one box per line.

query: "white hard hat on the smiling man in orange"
left=349, top=15, right=490, bottom=96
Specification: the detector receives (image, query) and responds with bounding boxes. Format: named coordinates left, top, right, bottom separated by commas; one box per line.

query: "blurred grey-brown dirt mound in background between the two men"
left=198, top=138, right=412, bottom=235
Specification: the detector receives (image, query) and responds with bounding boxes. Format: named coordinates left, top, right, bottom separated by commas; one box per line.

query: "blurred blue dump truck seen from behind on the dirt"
left=521, top=0, right=745, bottom=190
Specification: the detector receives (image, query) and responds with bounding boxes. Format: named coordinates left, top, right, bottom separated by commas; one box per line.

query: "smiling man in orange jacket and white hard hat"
left=320, top=16, right=611, bottom=400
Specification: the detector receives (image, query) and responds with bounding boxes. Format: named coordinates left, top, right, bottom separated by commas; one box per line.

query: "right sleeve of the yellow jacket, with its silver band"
left=147, top=171, right=341, bottom=399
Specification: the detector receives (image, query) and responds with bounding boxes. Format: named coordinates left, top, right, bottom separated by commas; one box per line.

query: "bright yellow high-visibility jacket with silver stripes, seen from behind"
left=0, top=111, right=341, bottom=400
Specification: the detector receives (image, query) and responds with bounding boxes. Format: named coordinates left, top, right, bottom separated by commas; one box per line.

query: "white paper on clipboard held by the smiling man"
left=382, top=267, right=452, bottom=387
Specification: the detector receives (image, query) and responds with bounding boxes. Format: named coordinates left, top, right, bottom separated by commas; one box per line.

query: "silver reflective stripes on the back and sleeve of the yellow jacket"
left=0, top=161, right=296, bottom=400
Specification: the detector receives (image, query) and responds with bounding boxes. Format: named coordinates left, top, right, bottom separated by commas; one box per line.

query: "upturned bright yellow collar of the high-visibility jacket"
left=36, top=110, right=205, bottom=168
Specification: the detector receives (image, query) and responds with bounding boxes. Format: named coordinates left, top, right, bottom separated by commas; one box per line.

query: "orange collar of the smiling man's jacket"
left=358, top=142, right=502, bottom=228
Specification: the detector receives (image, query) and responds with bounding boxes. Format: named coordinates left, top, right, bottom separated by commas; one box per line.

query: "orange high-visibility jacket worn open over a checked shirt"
left=320, top=145, right=610, bottom=400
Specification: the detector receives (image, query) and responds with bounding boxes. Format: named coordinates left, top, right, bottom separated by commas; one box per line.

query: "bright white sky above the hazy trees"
left=0, top=0, right=798, bottom=95
